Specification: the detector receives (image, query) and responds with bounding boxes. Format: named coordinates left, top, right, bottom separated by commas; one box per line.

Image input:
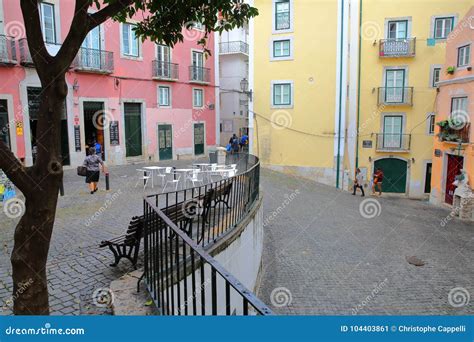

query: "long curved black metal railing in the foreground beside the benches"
left=143, top=156, right=272, bottom=315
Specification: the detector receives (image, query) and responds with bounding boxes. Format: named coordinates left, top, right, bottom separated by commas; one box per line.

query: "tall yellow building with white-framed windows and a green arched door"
left=250, top=0, right=471, bottom=197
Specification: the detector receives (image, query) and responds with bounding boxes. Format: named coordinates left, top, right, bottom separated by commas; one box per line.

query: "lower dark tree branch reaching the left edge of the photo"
left=0, top=140, right=36, bottom=196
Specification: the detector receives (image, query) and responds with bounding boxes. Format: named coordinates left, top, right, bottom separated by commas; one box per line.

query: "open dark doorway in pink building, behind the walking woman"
left=82, top=101, right=107, bottom=160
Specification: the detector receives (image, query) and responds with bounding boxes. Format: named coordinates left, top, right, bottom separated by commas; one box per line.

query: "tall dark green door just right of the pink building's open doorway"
left=124, top=103, right=142, bottom=157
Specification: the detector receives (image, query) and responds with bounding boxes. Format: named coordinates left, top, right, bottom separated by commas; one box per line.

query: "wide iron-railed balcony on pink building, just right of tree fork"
left=72, top=48, right=114, bottom=74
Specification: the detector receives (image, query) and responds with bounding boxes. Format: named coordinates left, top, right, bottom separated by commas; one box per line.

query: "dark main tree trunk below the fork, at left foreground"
left=11, top=73, right=67, bottom=315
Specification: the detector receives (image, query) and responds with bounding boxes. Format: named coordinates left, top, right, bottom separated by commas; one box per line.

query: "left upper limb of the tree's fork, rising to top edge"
left=20, top=0, right=52, bottom=79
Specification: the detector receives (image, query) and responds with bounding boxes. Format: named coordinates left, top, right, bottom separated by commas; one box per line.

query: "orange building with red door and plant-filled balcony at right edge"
left=430, top=7, right=474, bottom=220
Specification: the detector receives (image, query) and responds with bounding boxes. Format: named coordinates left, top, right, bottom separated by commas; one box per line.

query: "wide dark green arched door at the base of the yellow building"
left=374, top=158, right=408, bottom=194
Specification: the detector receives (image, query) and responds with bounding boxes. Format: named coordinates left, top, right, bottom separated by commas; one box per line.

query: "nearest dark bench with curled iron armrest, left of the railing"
left=99, top=216, right=144, bottom=269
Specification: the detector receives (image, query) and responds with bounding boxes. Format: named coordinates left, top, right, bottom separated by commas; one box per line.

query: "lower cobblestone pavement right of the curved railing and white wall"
left=258, top=170, right=474, bottom=315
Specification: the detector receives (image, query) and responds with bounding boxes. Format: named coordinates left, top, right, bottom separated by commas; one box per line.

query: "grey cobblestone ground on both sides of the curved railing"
left=0, top=165, right=474, bottom=315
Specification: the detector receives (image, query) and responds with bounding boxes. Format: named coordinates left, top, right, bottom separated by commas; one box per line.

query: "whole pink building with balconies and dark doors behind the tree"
left=0, top=0, right=219, bottom=166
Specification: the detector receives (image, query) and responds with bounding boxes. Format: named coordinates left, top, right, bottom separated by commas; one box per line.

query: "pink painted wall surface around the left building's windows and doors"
left=0, top=0, right=216, bottom=164
